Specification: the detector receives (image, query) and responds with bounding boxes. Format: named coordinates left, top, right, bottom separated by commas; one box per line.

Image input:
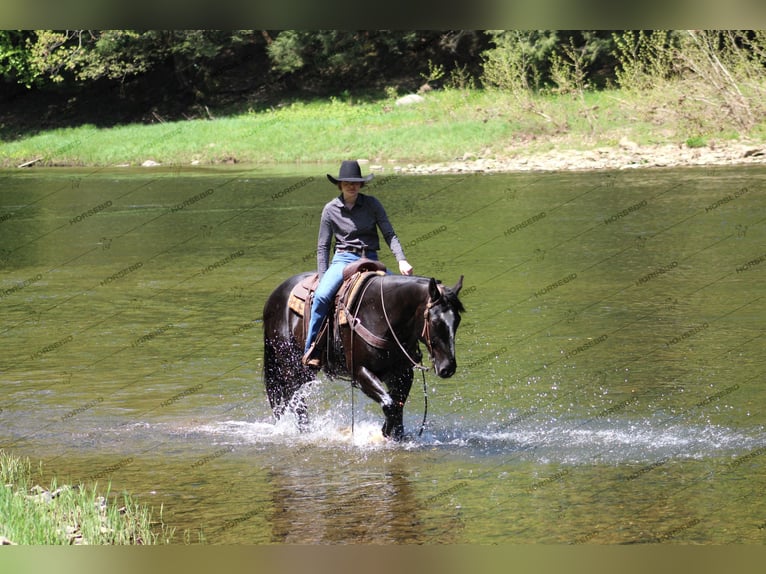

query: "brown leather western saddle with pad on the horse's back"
left=287, top=258, right=388, bottom=364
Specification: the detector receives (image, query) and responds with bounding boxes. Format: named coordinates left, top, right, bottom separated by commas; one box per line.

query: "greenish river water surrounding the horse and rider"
left=0, top=166, right=766, bottom=544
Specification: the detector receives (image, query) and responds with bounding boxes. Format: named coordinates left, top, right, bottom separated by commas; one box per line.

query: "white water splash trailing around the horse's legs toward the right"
left=182, top=413, right=766, bottom=464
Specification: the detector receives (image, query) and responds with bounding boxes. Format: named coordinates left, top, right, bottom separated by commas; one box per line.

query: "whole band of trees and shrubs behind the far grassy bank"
left=0, top=30, right=766, bottom=151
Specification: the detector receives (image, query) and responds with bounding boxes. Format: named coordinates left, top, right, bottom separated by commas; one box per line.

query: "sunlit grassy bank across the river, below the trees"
left=0, top=85, right=766, bottom=167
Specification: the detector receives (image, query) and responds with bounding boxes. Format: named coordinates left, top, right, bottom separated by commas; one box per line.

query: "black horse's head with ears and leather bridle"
left=423, top=275, right=465, bottom=379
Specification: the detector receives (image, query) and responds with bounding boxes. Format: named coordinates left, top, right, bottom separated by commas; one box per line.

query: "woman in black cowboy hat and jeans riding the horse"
left=303, top=161, right=412, bottom=369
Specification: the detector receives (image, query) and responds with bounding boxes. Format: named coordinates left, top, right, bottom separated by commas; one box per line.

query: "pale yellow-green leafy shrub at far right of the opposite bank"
left=614, top=30, right=766, bottom=137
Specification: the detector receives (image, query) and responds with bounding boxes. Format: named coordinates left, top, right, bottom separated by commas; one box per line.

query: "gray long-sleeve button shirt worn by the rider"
left=317, top=193, right=406, bottom=275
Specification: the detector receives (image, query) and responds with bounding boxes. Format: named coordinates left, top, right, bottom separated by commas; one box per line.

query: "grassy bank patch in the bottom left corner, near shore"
left=0, top=451, right=168, bottom=545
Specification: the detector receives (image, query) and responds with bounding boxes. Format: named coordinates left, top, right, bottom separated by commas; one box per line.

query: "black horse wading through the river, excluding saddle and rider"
left=263, top=273, right=464, bottom=440
